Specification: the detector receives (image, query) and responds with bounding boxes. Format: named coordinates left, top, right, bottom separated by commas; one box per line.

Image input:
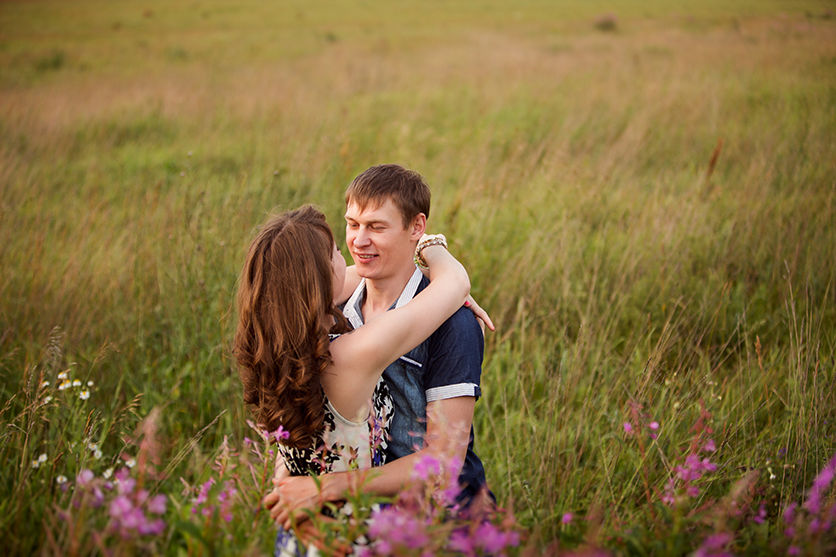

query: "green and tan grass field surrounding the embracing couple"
left=0, top=0, right=836, bottom=555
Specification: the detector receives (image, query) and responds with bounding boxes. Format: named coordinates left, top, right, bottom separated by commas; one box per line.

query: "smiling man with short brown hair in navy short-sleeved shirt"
left=265, top=164, right=489, bottom=528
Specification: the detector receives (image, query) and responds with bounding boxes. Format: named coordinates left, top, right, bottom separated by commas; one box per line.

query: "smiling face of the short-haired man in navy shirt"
left=345, top=199, right=423, bottom=280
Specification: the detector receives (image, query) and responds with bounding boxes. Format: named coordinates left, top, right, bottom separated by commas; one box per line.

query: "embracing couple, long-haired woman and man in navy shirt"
left=234, top=164, right=493, bottom=555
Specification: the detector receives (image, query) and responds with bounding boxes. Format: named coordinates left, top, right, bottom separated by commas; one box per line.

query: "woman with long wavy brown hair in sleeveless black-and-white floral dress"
left=234, top=206, right=470, bottom=553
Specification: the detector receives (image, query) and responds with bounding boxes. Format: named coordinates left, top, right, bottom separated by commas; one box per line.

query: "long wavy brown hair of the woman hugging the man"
left=233, top=205, right=350, bottom=449
